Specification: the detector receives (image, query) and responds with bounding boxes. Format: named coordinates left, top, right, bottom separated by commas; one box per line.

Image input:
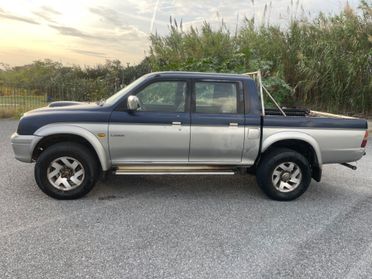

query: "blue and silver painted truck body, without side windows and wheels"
left=11, top=72, right=367, bottom=182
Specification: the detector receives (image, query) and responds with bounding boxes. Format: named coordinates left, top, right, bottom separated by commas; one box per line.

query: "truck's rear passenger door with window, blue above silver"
left=189, top=79, right=244, bottom=164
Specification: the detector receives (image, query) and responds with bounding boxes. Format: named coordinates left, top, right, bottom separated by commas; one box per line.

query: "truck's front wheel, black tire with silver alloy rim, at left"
left=35, top=142, right=99, bottom=200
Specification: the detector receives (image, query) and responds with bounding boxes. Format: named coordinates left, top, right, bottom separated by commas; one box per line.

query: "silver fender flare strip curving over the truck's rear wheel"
left=262, top=131, right=322, bottom=167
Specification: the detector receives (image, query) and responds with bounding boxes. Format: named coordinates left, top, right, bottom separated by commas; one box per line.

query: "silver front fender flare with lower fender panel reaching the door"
left=34, top=123, right=111, bottom=171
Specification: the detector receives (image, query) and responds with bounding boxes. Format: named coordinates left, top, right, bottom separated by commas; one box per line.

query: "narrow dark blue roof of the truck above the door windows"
left=148, top=71, right=251, bottom=79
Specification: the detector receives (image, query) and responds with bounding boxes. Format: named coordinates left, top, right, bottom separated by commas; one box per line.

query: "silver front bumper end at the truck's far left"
left=10, top=133, right=41, bottom=163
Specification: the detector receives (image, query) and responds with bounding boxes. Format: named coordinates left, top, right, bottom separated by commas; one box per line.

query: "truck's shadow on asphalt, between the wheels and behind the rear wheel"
left=87, top=175, right=359, bottom=203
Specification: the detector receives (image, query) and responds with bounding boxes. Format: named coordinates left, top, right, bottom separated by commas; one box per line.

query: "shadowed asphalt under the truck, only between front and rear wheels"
left=89, top=175, right=266, bottom=200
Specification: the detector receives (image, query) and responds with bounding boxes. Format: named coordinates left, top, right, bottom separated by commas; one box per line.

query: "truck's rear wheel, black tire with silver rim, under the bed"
left=256, top=148, right=311, bottom=201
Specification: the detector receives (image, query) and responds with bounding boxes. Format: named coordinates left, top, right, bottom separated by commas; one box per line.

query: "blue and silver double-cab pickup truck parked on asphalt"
left=11, top=72, right=368, bottom=201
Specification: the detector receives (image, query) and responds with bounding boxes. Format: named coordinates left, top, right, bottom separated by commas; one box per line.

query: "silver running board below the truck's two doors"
left=115, top=165, right=235, bottom=175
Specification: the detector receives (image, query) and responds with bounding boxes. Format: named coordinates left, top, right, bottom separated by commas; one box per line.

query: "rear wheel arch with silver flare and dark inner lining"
left=261, top=132, right=322, bottom=181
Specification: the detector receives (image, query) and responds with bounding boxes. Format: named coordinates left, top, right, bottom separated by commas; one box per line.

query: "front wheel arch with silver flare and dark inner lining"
left=32, top=125, right=111, bottom=171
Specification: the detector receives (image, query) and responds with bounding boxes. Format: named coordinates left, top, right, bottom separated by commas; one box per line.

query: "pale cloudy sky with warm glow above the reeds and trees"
left=0, top=0, right=359, bottom=66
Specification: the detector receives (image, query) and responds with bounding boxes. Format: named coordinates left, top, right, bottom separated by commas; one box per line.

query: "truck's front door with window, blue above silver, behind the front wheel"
left=109, top=80, right=190, bottom=165
